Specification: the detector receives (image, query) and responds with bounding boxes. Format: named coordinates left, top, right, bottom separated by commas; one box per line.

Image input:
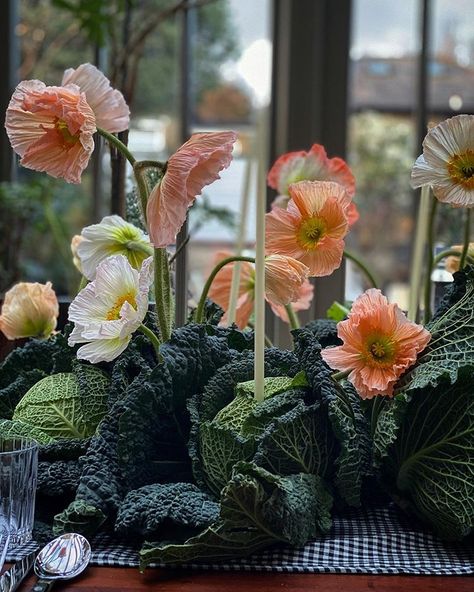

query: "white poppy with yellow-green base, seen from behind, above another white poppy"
left=76, top=215, right=153, bottom=280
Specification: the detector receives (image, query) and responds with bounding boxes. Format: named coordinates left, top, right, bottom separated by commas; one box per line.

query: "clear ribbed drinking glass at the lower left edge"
left=0, top=437, right=38, bottom=559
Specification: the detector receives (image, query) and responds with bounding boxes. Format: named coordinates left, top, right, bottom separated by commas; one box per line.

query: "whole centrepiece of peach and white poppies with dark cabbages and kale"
left=0, top=64, right=474, bottom=567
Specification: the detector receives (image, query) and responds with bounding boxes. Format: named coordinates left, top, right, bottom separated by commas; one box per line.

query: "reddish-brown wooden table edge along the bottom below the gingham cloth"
left=10, top=567, right=474, bottom=592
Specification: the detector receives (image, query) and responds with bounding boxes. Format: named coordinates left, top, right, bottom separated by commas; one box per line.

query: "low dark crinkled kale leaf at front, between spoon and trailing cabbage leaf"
left=115, top=483, right=219, bottom=540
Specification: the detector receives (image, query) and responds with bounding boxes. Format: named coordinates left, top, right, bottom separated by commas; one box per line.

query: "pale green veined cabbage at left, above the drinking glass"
left=13, top=364, right=109, bottom=438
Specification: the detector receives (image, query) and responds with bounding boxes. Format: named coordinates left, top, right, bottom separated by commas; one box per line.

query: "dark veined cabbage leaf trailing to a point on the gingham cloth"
left=140, top=463, right=332, bottom=569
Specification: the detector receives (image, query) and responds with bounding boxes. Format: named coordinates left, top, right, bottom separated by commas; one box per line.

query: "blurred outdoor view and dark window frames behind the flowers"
left=0, top=0, right=474, bottom=340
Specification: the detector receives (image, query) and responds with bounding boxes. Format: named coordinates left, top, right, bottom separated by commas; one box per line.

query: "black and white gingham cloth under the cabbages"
left=7, top=506, right=474, bottom=575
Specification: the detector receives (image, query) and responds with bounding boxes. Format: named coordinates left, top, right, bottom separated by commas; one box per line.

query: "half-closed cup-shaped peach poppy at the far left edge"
left=0, top=282, right=59, bottom=340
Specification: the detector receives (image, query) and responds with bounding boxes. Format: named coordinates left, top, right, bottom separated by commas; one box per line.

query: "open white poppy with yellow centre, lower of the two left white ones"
left=68, top=255, right=153, bottom=364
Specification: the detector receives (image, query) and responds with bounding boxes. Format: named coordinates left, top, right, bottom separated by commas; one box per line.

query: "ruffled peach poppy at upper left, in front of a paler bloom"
left=5, top=80, right=96, bottom=183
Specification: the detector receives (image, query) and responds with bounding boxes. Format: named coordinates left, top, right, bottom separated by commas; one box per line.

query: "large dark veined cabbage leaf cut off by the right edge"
left=374, top=366, right=474, bottom=539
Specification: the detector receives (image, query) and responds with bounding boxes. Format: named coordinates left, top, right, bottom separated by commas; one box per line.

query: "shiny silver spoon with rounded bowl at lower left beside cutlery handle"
left=31, top=533, right=91, bottom=592
